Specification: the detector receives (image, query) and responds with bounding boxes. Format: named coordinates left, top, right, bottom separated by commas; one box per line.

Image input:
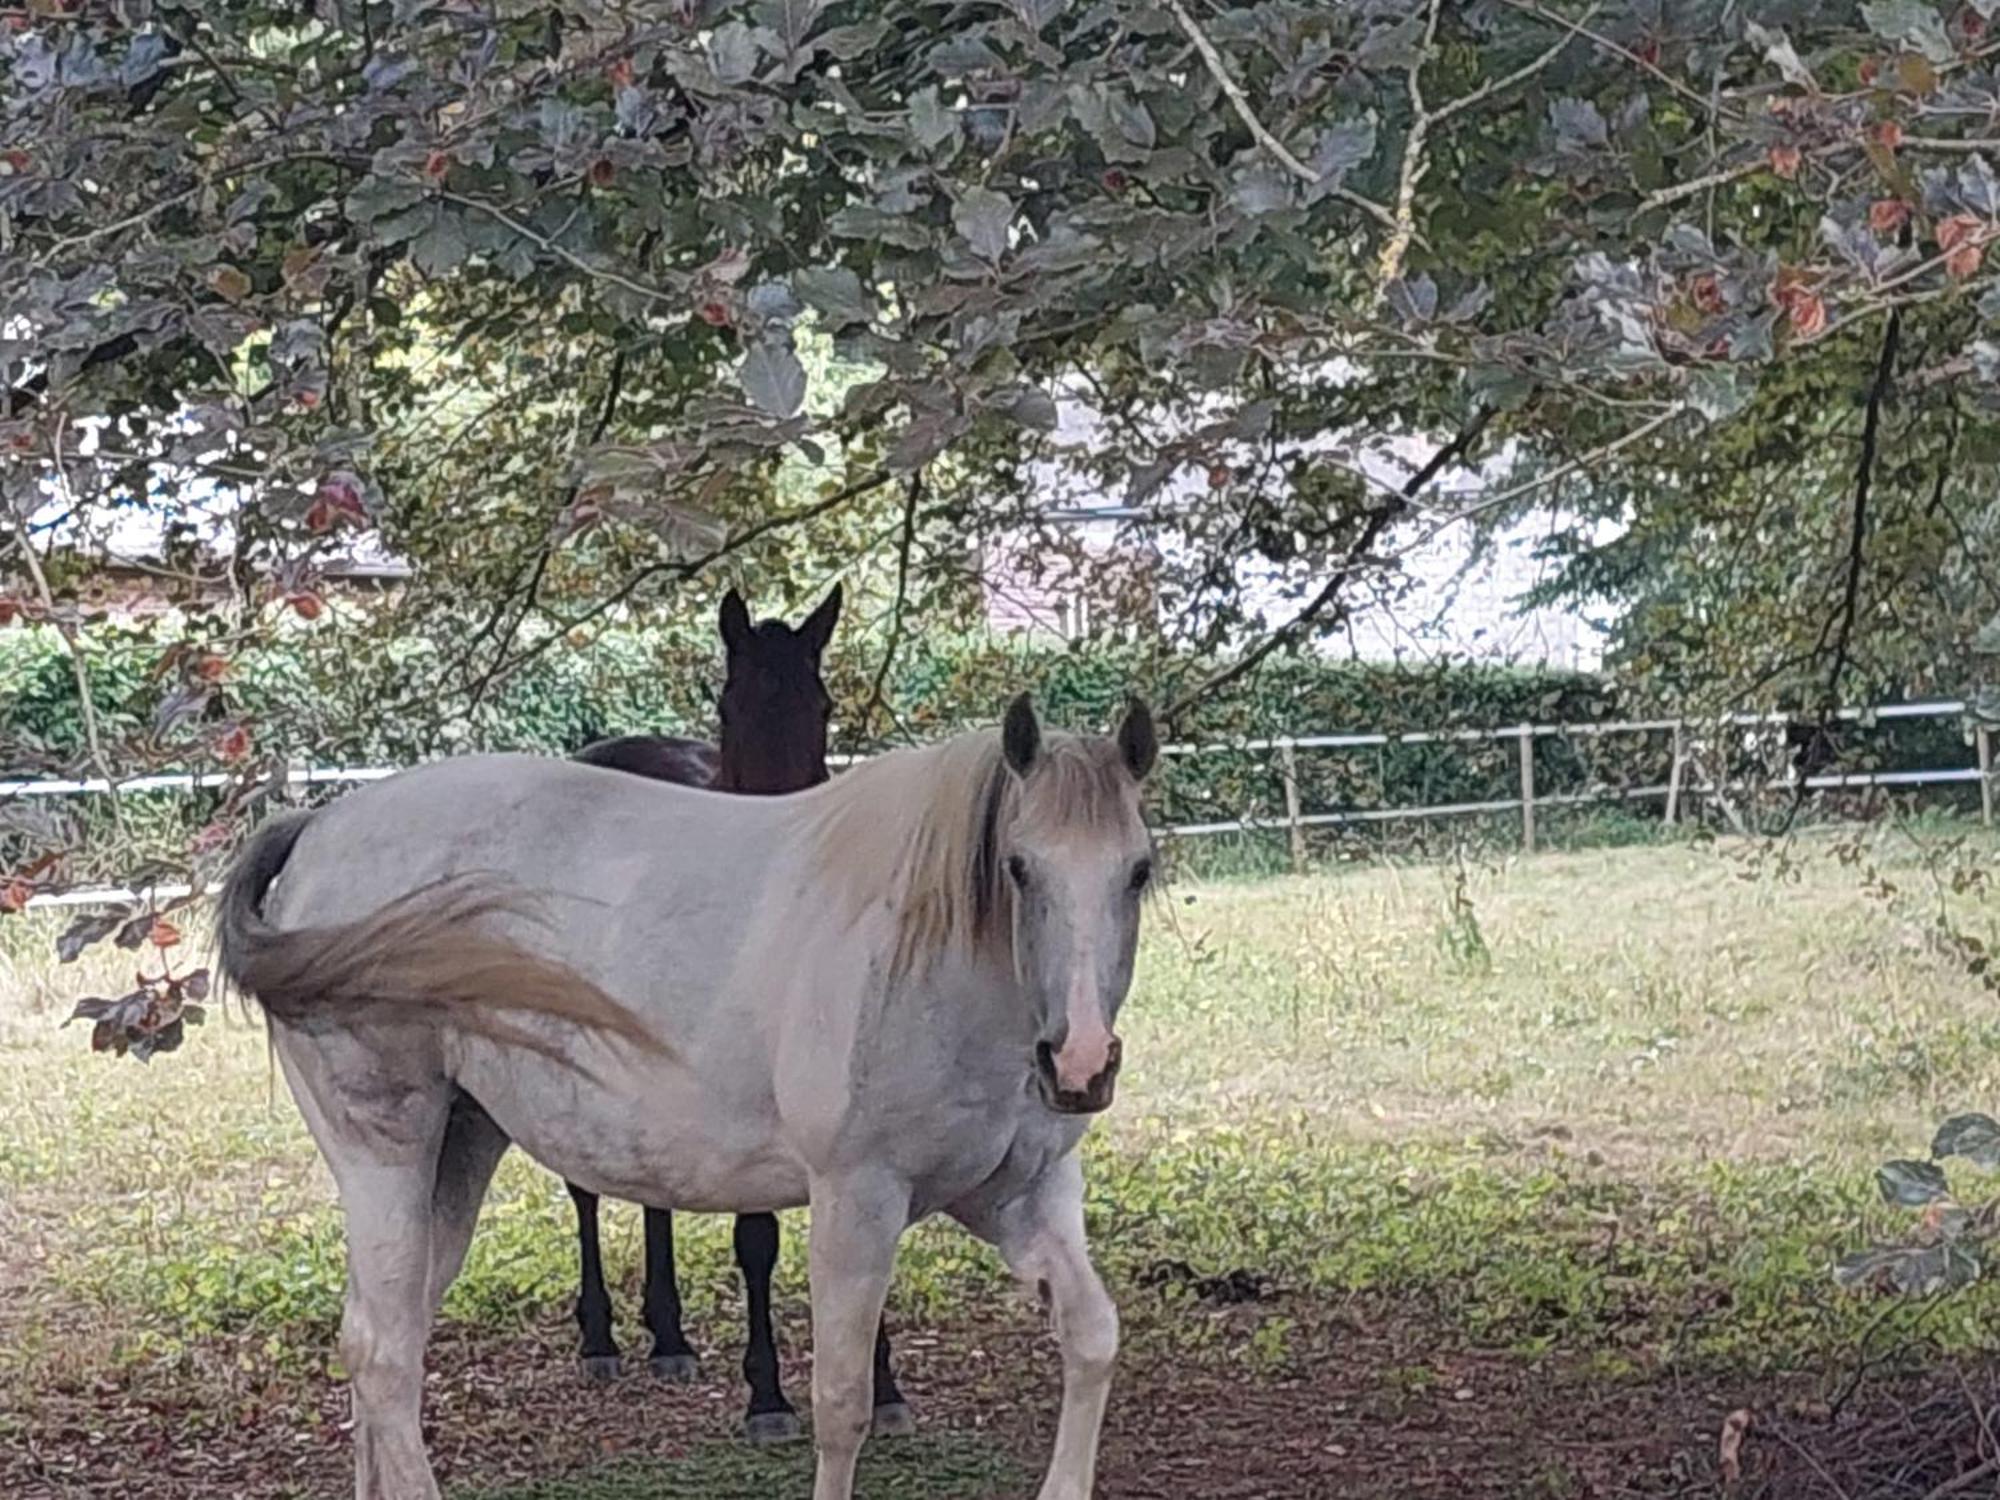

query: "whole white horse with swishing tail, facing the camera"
left=220, top=698, right=1156, bottom=1500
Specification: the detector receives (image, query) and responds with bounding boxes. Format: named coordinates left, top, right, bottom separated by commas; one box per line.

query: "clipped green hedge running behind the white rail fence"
left=0, top=626, right=1970, bottom=888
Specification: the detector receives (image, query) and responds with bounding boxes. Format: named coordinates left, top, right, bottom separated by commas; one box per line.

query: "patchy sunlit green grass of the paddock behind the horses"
left=0, top=824, right=2000, bottom=1424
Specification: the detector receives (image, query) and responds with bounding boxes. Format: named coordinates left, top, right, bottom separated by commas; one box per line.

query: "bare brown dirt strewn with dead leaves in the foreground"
left=0, top=1308, right=2000, bottom=1500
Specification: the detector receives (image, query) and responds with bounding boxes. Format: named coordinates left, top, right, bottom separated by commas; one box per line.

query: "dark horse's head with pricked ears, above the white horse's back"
left=714, top=584, right=840, bottom=794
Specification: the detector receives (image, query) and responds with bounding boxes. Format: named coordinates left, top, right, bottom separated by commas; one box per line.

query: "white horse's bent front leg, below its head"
left=962, top=1152, right=1118, bottom=1500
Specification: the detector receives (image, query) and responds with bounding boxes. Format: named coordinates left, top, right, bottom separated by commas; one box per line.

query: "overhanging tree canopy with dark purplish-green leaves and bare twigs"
left=0, top=0, right=2000, bottom=756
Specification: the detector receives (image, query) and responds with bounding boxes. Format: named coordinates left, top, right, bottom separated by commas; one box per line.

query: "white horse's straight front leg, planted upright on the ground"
left=810, top=1176, right=910, bottom=1500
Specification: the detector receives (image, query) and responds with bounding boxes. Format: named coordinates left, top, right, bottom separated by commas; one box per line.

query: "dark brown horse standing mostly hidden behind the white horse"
left=570, top=586, right=912, bottom=1442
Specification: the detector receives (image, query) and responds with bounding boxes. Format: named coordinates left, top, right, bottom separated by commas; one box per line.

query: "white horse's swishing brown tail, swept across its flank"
left=216, top=812, right=670, bottom=1056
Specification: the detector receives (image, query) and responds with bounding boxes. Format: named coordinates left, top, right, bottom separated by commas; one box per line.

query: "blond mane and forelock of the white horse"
left=806, top=730, right=1134, bottom=980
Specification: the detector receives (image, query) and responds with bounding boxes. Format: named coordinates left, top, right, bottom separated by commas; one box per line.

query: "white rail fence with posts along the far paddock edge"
left=0, top=700, right=2000, bottom=908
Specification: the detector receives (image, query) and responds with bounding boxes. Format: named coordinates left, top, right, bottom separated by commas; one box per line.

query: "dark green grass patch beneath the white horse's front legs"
left=452, top=1436, right=1030, bottom=1500
